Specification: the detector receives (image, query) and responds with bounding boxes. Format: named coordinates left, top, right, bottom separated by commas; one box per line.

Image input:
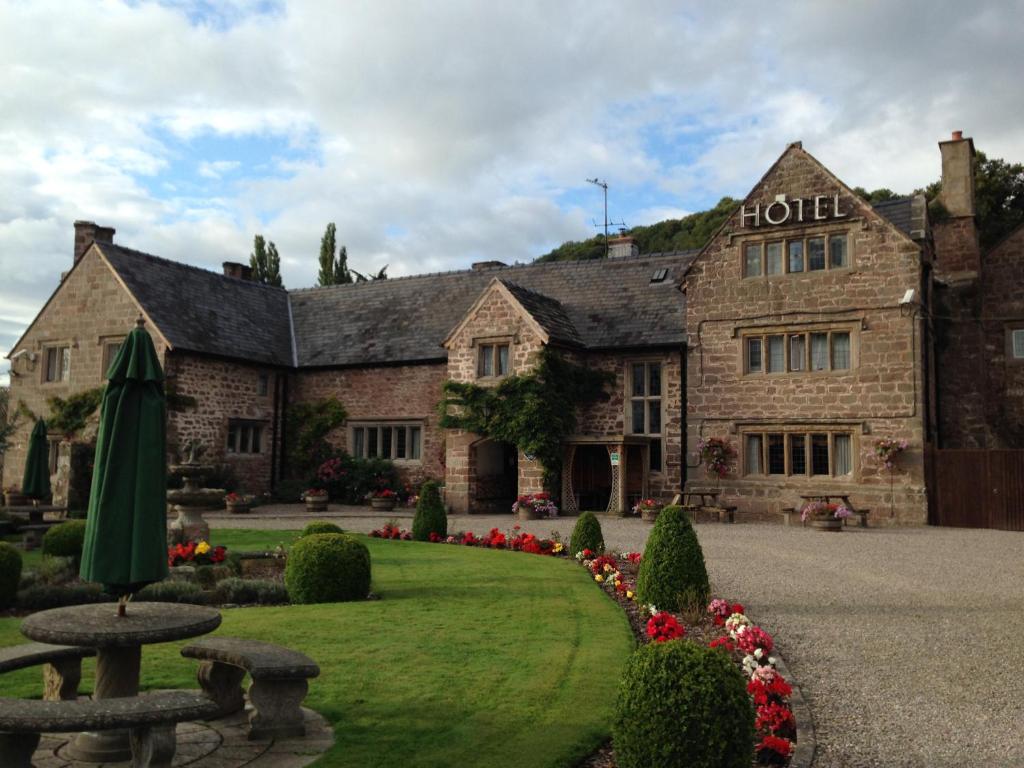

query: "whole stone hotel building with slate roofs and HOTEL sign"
left=3, top=133, right=1024, bottom=526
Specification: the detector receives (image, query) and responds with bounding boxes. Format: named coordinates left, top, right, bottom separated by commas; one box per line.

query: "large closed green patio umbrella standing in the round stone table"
left=80, top=318, right=167, bottom=614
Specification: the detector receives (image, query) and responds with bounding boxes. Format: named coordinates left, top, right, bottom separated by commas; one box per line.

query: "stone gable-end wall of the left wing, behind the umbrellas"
left=3, top=249, right=165, bottom=494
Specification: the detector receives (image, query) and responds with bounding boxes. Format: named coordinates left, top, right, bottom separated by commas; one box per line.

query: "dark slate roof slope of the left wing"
left=95, top=243, right=293, bottom=367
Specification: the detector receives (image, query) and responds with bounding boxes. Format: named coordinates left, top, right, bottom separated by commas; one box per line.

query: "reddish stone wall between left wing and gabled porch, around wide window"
left=289, top=364, right=446, bottom=484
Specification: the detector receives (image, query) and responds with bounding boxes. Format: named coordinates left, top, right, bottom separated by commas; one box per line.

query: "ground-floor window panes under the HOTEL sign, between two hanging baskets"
left=741, top=427, right=854, bottom=477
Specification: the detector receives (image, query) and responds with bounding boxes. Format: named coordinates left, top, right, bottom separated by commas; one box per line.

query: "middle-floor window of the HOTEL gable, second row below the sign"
left=741, top=328, right=854, bottom=374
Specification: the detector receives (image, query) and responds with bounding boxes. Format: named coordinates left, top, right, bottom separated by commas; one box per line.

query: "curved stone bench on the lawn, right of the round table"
left=181, top=637, right=319, bottom=739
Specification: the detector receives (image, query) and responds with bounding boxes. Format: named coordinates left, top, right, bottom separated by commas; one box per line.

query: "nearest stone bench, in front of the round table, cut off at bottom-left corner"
left=0, top=691, right=218, bottom=768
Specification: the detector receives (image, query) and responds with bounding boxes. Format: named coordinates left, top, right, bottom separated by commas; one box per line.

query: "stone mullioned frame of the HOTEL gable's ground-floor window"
left=737, top=423, right=862, bottom=482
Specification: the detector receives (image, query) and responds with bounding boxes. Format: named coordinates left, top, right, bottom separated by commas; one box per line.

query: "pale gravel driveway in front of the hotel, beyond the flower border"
left=208, top=506, right=1024, bottom=768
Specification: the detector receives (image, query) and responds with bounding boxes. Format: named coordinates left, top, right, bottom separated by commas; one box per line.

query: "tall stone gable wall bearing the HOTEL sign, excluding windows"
left=686, top=146, right=927, bottom=524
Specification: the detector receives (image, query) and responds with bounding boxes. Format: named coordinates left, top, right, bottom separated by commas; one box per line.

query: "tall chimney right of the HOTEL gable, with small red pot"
left=932, top=131, right=981, bottom=285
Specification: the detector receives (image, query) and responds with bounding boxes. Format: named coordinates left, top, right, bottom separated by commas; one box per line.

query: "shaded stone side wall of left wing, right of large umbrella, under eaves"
left=166, top=351, right=284, bottom=494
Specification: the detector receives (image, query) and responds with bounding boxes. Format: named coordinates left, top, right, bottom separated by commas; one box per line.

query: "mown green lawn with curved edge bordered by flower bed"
left=0, top=530, right=633, bottom=768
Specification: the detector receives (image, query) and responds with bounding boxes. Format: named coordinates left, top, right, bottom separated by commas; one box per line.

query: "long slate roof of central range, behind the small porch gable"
left=290, top=251, right=697, bottom=368
